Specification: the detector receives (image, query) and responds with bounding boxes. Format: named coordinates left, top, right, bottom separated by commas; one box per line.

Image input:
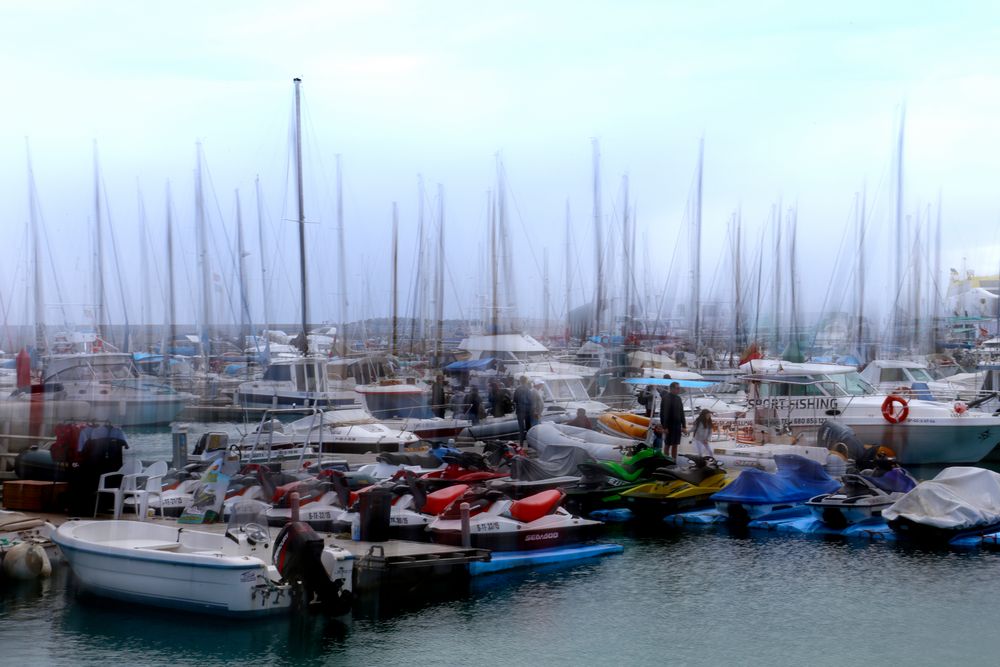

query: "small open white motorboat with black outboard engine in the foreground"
left=52, top=511, right=354, bottom=616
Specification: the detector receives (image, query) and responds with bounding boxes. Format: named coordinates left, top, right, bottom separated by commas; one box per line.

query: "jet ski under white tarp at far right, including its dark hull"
left=882, top=466, right=1000, bottom=544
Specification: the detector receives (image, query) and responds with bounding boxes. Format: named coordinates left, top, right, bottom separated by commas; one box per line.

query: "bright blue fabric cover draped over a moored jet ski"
left=712, top=454, right=840, bottom=505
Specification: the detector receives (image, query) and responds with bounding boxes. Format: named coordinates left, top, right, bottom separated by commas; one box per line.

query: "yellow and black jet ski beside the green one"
left=622, top=456, right=732, bottom=519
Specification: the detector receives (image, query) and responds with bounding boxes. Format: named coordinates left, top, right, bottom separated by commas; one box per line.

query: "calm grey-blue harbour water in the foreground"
left=0, top=426, right=1000, bottom=667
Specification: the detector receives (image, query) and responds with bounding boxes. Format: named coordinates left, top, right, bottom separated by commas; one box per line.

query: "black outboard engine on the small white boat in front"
left=272, top=521, right=351, bottom=614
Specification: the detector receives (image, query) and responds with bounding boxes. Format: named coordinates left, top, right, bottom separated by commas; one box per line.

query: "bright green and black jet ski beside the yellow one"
left=565, top=442, right=674, bottom=515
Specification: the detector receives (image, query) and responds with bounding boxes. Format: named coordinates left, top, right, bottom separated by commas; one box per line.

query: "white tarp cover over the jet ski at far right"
left=882, top=466, right=1000, bottom=529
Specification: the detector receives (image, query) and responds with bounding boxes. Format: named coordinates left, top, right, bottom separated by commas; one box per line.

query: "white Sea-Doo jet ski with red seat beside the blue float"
left=427, top=487, right=601, bottom=551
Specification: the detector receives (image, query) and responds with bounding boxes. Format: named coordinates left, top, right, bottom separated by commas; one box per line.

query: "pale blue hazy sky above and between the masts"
left=0, top=0, right=1000, bottom=340
